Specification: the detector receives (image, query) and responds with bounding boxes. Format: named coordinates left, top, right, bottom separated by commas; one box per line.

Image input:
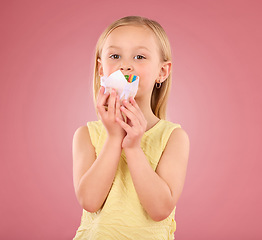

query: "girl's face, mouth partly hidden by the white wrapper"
left=98, top=26, right=170, bottom=98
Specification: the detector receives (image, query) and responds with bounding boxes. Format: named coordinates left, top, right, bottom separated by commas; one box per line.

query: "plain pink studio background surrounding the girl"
left=0, top=0, right=262, bottom=240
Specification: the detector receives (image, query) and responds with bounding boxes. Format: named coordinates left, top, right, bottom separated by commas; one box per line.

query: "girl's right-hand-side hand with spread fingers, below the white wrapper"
left=116, top=98, right=147, bottom=148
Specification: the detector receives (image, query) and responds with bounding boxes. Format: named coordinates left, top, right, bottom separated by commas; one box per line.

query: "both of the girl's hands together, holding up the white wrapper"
left=97, top=87, right=147, bottom=149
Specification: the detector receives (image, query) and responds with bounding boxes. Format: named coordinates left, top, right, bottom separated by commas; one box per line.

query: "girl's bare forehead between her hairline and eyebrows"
left=104, top=25, right=158, bottom=49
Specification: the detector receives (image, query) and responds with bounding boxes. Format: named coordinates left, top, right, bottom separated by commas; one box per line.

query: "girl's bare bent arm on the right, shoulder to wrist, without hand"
left=125, top=128, right=189, bottom=221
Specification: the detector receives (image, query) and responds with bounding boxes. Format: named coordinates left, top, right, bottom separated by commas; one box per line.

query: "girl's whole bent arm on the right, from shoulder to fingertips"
left=117, top=98, right=189, bottom=221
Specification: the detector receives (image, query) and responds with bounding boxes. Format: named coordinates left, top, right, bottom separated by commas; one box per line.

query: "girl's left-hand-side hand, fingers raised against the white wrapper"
left=96, top=87, right=126, bottom=141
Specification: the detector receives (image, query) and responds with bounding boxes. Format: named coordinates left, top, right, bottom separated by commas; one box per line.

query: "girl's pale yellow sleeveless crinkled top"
left=73, top=119, right=181, bottom=240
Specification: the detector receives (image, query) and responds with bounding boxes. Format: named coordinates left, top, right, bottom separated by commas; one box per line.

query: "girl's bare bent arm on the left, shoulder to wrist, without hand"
left=73, top=126, right=121, bottom=212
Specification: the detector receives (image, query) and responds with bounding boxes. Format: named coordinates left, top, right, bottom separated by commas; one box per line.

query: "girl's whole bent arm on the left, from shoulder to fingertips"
left=73, top=87, right=124, bottom=212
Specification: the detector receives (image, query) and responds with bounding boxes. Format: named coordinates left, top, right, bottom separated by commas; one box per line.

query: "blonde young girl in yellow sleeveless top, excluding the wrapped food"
left=73, top=16, right=189, bottom=240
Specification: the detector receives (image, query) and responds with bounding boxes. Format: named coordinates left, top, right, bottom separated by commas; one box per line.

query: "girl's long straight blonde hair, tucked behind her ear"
left=93, top=16, right=172, bottom=119
